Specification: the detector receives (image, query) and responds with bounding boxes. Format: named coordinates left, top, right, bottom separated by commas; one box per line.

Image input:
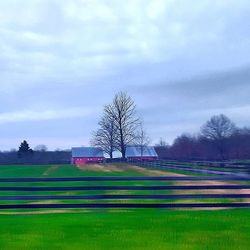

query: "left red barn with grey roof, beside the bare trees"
left=71, top=147, right=105, bottom=165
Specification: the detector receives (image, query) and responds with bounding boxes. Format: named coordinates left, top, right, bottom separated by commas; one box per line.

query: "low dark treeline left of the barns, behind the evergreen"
left=0, top=151, right=71, bottom=165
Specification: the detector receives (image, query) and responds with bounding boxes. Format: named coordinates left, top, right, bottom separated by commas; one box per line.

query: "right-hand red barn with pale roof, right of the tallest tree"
left=126, top=146, right=158, bottom=161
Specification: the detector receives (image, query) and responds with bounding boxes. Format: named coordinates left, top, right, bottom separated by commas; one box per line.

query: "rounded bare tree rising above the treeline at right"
left=201, top=114, right=236, bottom=159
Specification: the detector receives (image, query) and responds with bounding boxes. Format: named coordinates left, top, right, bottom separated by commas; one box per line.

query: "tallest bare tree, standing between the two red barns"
left=104, top=92, right=139, bottom=158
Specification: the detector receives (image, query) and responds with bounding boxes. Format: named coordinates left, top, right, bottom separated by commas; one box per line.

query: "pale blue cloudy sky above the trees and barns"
left=0, top=0, right=250, bottom=150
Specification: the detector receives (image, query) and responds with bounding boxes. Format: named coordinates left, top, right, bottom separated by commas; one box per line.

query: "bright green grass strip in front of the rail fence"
left=0, top=209, right=250, bottom=250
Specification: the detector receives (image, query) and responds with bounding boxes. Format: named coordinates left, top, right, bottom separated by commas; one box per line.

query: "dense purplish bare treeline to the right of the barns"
left=156, top=114, right=250, bottom=160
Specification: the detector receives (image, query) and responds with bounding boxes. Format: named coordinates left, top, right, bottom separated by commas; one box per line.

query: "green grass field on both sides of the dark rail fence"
left=0, top=165, right=250, bottom=250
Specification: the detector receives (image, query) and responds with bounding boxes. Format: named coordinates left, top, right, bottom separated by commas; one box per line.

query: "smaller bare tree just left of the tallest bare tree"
left=90, top=115, right=116, bottom=158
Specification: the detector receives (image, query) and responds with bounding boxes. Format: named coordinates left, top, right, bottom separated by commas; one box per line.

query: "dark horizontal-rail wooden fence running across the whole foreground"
left=0, top=176, right=250, bottom=210
